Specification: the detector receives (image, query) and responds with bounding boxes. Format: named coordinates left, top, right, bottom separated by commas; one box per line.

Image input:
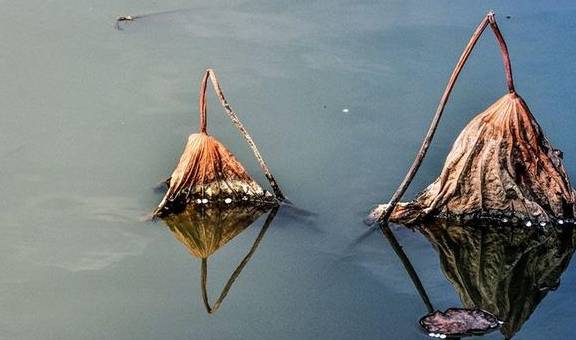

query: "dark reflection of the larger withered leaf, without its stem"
left=419, top=224, right=575, bottom=338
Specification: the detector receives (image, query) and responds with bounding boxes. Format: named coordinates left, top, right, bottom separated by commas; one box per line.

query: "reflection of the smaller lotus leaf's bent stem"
left=200, top=207, right=278, bottom=314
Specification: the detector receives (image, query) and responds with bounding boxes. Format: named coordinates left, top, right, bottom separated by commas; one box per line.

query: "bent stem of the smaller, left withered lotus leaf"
left=199, top=69, right=285, bottom=201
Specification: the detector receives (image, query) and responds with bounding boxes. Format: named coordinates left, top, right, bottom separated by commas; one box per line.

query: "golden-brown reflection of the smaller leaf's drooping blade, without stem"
left=164, top=202, right=268, bottom=258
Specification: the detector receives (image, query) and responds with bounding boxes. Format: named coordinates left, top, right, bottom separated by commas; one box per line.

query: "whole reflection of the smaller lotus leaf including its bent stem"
left=164, top=205, right=278, bottom=314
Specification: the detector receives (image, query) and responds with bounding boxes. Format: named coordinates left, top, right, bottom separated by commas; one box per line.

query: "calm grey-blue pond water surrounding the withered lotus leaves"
left=0, top=0, right=576, bottom=340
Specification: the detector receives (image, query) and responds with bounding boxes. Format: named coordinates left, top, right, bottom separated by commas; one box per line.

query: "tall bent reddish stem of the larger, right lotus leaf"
left=378, top=12, right=515, bottom=223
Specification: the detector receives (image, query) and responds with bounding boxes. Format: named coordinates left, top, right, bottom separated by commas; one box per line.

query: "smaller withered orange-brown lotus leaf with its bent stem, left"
left=154, top=69, right=284, bottom=216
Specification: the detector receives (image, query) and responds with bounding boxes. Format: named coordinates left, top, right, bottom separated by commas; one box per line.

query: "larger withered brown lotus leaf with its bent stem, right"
left=368, top=12, right=576, bottom=225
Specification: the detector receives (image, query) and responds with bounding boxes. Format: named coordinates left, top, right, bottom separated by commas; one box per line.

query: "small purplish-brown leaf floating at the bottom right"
left=420, top=308, right=502, bottom=339
